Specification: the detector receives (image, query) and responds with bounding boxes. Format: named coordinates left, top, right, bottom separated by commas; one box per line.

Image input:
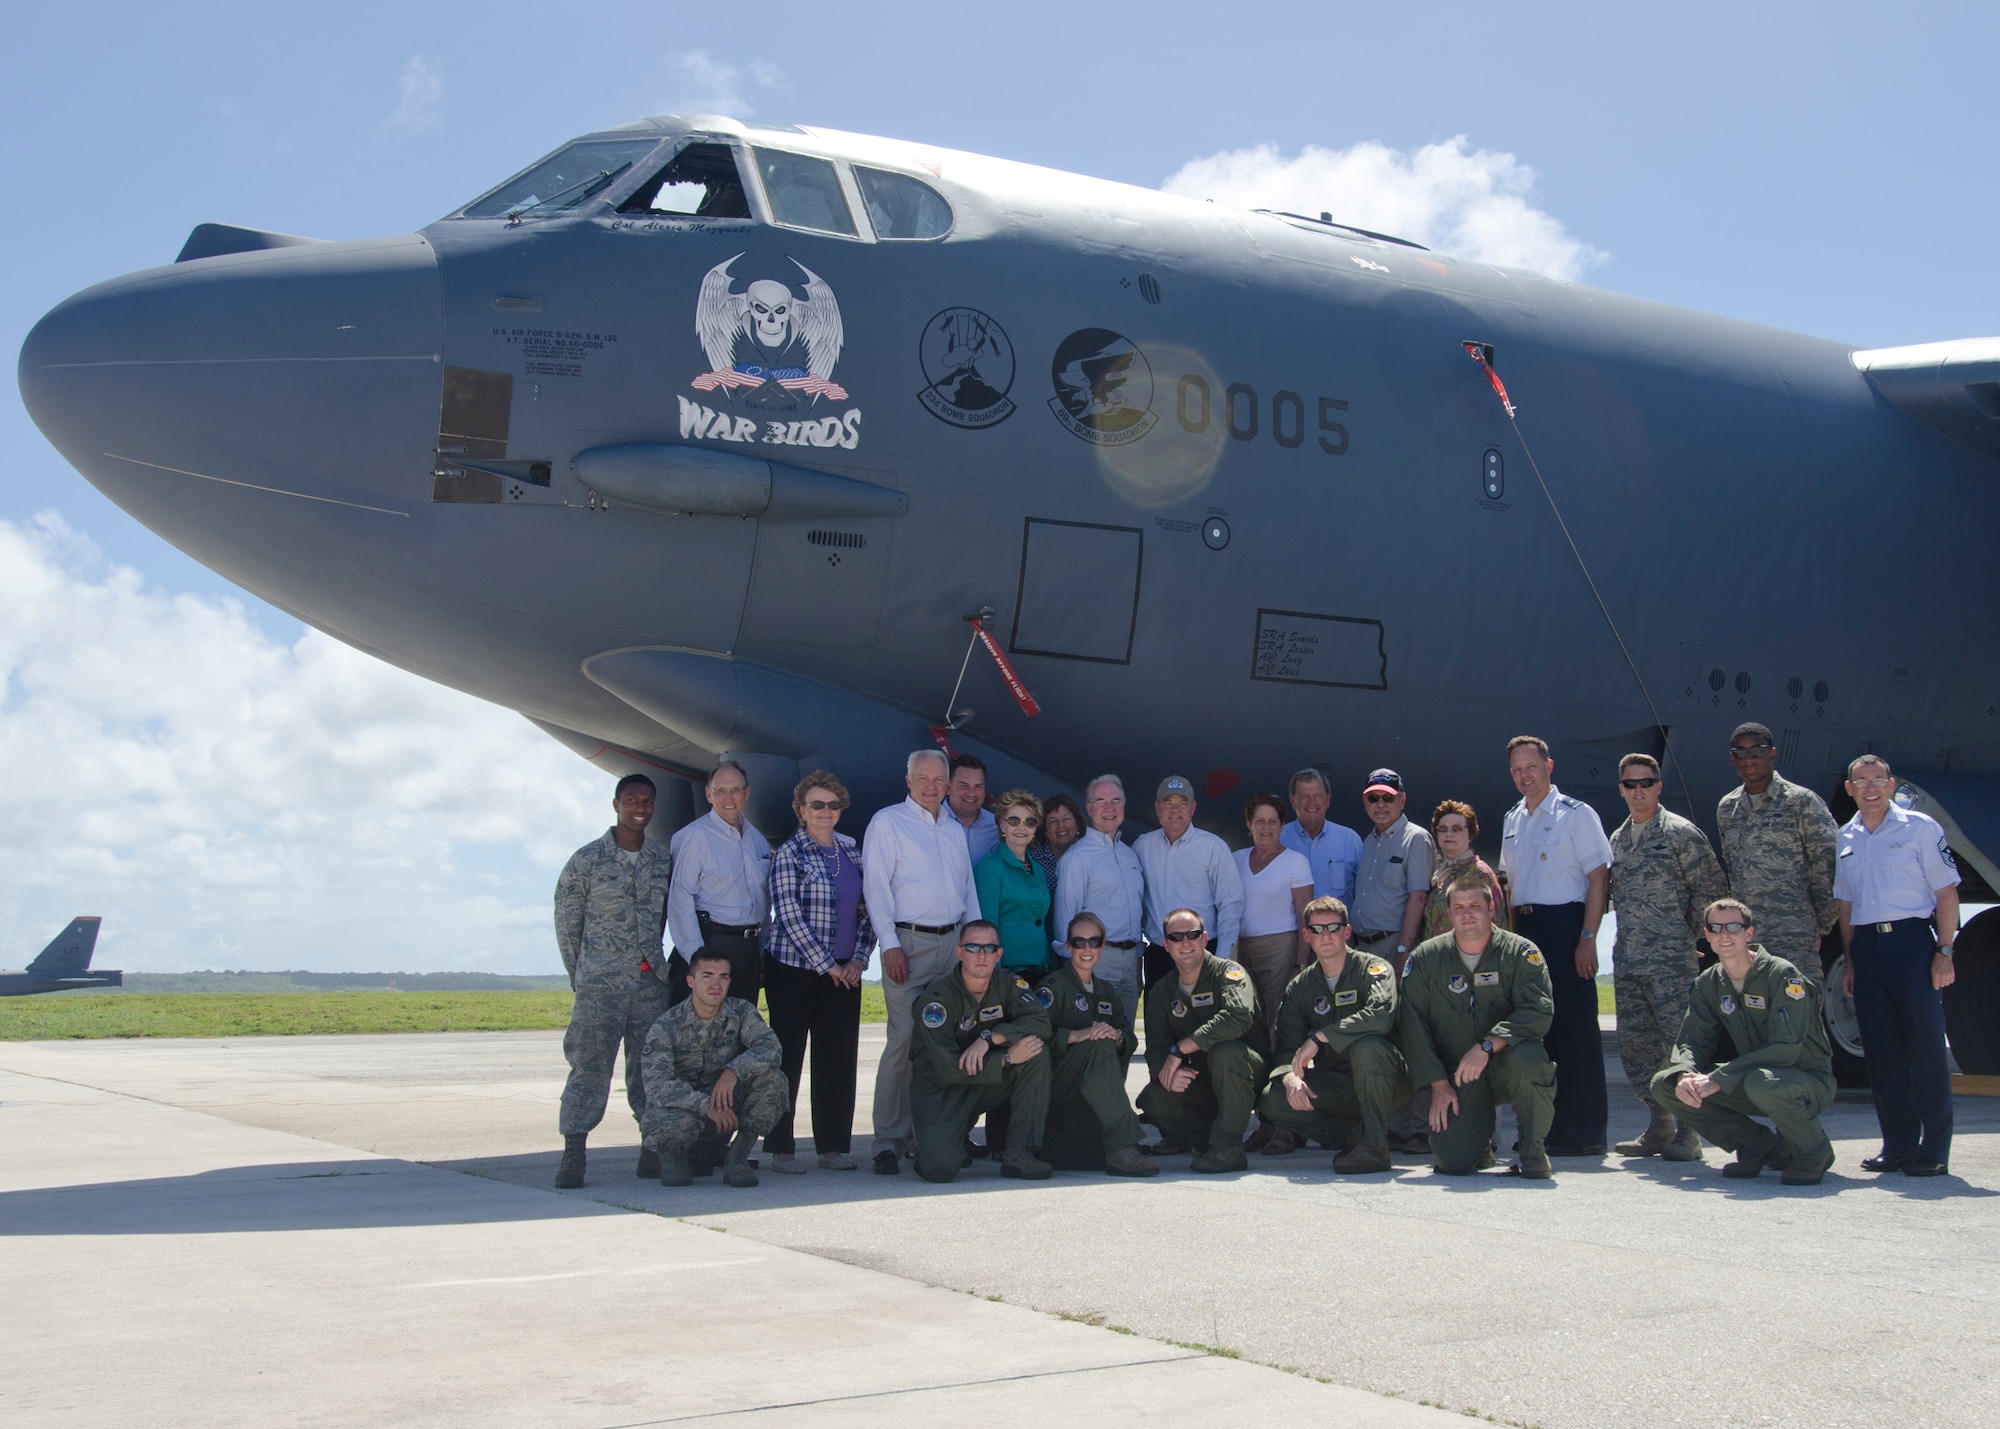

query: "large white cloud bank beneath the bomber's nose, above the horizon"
left=0, top=514, right=610, bottom=973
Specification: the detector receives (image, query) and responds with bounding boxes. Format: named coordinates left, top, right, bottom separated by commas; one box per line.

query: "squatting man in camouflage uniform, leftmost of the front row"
left=640, top=949, right=790, bottom=1187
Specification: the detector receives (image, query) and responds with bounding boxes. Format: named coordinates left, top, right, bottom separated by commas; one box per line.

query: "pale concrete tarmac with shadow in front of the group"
left=0, top=1029, right=2000, bottom=1429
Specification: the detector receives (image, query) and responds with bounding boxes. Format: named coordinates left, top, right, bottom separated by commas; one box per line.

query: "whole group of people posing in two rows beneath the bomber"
left=556, top=725, right=1958, bottom=1187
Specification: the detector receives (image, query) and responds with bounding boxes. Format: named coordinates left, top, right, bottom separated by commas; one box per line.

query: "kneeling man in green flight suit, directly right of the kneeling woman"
left=1138, top=909, right=1264, bottom=1175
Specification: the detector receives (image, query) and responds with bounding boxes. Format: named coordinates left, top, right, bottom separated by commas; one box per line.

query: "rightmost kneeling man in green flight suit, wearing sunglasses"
left=1652, top=899, right=1834, bottom=1187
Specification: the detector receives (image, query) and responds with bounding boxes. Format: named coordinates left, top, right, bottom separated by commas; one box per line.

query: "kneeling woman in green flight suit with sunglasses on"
left=1034, top=913, right=1160, bottom=1177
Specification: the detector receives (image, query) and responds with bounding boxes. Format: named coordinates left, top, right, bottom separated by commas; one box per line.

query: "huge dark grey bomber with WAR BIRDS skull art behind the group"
left=20, top=116, right=2000, bottom=1071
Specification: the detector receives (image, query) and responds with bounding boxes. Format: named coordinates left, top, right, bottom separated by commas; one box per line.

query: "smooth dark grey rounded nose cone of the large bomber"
left=20, top=236, right=442, bottom=608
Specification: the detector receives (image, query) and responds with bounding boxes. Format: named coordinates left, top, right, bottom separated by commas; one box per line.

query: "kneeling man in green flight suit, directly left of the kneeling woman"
left=910, top=919, right=1052, bottom=1185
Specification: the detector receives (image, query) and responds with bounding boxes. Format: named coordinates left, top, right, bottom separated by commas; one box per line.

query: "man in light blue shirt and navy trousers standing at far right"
left=1834, top=755, right=1958, bottom=1177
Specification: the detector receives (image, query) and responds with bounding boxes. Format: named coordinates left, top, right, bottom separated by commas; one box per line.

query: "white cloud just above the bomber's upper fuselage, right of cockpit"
left=1162, top=134, right=1610, bottom=282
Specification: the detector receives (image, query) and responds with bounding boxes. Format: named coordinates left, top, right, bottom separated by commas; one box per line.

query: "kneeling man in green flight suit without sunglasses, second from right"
left=1396, top=875, right=1556, bottom=1181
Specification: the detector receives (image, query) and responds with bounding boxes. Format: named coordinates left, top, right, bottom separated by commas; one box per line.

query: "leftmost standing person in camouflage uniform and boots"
left=556, top=775, right=674, bottom=1191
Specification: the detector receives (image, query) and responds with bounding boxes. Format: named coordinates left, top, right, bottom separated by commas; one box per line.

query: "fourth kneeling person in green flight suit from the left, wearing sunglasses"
left=1258, top=899, right=1410, bottom=1175
